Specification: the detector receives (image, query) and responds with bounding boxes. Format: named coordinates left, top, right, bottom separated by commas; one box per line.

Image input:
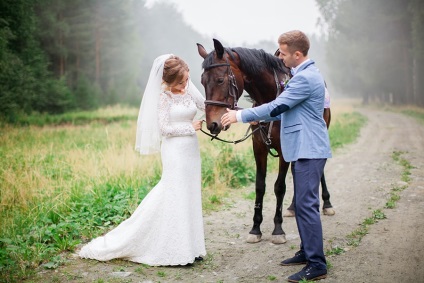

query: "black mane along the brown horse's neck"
left=202, top=47, right=288, bottom=76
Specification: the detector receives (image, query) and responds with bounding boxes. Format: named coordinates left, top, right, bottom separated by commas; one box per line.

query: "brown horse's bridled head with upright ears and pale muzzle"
left=197, top=39, right=244, bottom=134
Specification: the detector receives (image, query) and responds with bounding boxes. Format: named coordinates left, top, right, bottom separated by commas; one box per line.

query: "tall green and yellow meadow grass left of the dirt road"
left=0, top=107, right=365, bottom=282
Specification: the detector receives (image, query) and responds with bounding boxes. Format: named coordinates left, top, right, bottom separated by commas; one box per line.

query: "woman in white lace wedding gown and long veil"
left=79, top=54, right=206, bottom=266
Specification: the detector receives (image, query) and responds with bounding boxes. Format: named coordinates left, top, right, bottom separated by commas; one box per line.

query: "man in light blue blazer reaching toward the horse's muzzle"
left=221, top=30, right=331, bottom=282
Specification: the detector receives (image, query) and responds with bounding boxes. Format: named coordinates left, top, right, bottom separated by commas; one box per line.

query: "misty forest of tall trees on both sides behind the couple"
left=0, top=0, right=424, bottom=123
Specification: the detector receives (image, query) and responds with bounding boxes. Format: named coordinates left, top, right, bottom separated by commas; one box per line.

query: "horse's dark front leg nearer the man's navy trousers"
left=272, top=155, right=290, bottom=244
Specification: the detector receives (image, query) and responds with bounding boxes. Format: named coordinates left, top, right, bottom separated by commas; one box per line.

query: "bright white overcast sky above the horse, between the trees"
left=146, top=0, right=321, bottom=45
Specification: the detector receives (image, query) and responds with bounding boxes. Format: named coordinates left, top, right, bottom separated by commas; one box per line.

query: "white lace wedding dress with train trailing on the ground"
left=79, top=91, right=206, bottom=266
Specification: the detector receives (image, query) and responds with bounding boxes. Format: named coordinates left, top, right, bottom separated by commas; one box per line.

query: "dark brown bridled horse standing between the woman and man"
left=197, top=39, right=334, bottom=244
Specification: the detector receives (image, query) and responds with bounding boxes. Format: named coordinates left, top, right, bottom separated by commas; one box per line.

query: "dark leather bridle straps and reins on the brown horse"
left=200, top=60, right=281, bottom=157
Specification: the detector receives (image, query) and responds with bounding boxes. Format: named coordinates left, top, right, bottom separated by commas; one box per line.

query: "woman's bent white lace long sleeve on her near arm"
left=158, top=93, right=196, bottom=137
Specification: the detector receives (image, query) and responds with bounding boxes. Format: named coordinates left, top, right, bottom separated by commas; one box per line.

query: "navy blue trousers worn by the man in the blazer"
left=291, top=159, right=327, bottom=269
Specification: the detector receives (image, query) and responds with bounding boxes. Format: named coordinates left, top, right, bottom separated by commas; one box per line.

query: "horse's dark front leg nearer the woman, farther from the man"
left=247, top=142, right=268, bottom=243
